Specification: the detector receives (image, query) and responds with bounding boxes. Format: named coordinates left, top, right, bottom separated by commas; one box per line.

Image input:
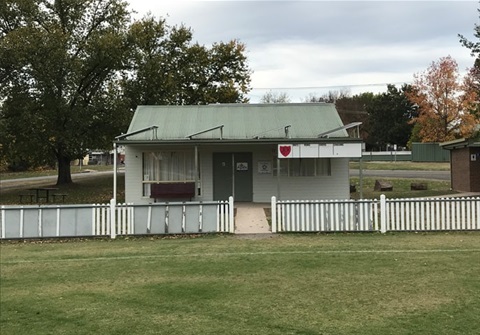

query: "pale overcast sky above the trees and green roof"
left=127, top=0, right=480, bottom=102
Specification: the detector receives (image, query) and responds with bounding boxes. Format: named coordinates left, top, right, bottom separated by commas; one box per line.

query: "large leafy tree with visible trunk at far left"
left=0, top=0, right=130, bottom=184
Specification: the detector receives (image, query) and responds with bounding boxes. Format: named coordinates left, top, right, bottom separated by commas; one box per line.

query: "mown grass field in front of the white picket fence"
left=0, top=233, right=480, bottom=335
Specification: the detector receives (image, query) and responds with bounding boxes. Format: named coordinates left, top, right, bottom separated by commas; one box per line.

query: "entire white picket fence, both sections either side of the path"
left=0, top=195, right=480, bottom=239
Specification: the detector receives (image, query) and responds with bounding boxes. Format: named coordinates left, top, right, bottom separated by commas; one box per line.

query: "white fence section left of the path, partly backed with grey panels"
left=0, top=198, right=234, bottom=239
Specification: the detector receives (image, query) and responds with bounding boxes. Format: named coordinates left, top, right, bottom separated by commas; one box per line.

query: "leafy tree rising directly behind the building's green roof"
left=120, top=15, right=251, bottom=109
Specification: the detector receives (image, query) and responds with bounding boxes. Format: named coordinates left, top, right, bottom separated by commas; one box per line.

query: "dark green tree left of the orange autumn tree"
left=365, top=85, right=416, bottom=148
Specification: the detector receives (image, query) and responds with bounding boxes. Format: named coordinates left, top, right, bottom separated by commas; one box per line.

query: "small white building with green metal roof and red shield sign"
left=116, top=103, right=361, bottom=203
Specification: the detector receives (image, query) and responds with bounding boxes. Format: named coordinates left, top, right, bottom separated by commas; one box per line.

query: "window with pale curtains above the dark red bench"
left=143, top=150, right=200, bottom=196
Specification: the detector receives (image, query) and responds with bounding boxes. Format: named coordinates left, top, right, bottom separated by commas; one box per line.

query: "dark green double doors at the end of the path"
left=213, top=152, right=253, bottom=202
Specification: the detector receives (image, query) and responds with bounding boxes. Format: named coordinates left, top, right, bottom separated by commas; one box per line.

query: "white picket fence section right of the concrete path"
left=271, top=195, right=480, bottom=233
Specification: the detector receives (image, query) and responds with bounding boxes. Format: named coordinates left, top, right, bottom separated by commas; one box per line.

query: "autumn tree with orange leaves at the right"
left=406, top=56, right=480, bottom=142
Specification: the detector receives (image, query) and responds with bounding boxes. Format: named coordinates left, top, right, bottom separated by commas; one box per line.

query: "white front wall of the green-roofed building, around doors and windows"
left=125, top=145, right=350, bottom=204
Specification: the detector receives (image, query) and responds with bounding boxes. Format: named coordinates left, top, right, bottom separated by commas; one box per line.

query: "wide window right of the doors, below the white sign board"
left=273, top=158, right=332, bottom=177
